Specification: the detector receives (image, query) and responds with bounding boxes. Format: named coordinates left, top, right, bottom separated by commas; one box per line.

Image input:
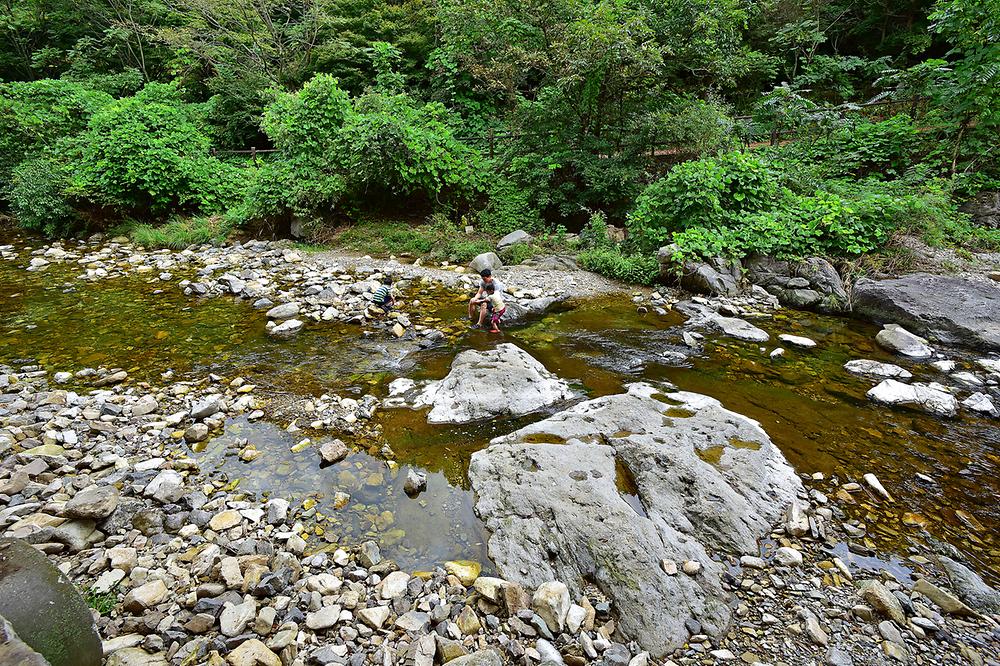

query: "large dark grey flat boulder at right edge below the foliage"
left=854, top=273, right=1000, bottom=349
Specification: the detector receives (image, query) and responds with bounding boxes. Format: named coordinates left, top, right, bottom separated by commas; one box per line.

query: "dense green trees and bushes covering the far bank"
left=0, top=0, right=1000, bottom=274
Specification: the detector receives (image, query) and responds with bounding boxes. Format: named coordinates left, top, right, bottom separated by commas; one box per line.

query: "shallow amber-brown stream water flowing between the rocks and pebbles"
left=0, top=239, right=1000, bottom=582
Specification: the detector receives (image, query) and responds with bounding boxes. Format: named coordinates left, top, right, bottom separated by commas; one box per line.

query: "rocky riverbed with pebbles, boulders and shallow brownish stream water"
left=0, top=230, right=1000, bottom=666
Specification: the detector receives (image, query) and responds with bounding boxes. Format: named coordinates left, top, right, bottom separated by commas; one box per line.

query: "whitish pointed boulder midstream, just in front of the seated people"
left=415, top=343, right=573, bottom=423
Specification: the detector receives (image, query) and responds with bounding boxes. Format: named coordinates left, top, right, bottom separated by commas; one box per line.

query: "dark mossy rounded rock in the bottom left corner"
left=0, top=539, right=103, bottom=666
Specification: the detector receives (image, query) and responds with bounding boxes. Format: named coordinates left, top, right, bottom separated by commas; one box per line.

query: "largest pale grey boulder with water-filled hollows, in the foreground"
left=469, top=384, right=801, bottom=656
